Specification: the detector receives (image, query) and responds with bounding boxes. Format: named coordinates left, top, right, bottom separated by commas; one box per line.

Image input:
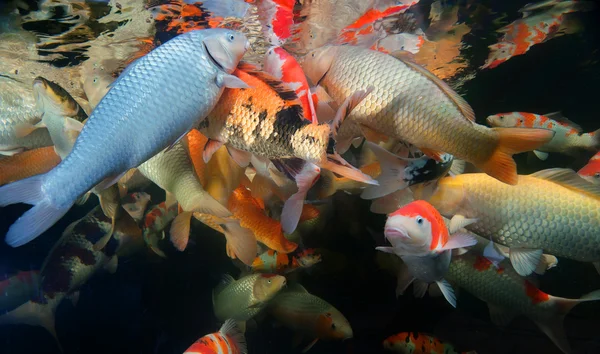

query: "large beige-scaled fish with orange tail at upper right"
left=301, top=46, right=553, bottom=184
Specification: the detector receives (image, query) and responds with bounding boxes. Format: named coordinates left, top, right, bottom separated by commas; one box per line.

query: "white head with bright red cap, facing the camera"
left=384, top=200, right=448, bottom=255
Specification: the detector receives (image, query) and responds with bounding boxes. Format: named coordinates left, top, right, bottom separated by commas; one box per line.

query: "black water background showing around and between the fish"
left=0, top=0, right=600, bottom=354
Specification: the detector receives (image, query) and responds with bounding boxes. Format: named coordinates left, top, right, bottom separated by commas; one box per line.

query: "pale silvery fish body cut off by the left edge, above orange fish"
left=0, top=77, right=53, bottom=155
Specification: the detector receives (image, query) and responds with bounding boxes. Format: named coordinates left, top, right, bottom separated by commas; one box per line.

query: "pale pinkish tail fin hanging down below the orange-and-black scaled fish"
left=281, top=163, right=321, bottom=234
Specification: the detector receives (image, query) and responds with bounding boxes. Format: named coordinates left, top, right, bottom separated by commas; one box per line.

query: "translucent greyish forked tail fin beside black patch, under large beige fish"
left=360, top=142, right=409, bottom=199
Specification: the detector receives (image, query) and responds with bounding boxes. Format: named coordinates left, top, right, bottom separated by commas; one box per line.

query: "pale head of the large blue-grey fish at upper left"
left=202, top=28, right=250, bottom=74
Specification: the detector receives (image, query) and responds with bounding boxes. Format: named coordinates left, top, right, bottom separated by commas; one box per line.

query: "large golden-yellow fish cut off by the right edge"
left=415, top=169, right=600, bottom=275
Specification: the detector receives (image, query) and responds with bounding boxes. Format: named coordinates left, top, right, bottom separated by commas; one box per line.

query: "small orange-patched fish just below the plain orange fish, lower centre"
left=252, top=249, right=321, bottom=274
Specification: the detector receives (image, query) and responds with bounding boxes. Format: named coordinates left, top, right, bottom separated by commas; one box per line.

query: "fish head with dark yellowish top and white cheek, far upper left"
left=33, top=76, right=87, bottom=121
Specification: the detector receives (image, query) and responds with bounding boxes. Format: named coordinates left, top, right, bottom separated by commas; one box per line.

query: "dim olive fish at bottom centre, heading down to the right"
left=268, top=284, right=354, bottom=352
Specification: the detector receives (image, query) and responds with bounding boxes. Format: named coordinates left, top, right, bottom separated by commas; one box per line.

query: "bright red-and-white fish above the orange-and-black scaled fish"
left=263, top=47, right=319, bottom=124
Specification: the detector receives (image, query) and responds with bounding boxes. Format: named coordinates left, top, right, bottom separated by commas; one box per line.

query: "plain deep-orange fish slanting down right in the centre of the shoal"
left=228, top=186, right=298, bottom=253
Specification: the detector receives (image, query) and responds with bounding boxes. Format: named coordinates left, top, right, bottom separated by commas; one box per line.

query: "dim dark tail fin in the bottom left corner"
left=0, top=301, right=63, bottom=352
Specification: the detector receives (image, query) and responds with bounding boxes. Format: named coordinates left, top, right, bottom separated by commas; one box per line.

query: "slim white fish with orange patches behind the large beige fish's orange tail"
left=487, top=112, right=600, bottom=160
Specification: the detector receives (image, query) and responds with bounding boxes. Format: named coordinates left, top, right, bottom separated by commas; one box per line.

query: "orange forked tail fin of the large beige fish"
left=477, top=128, right=554, bottom=185
